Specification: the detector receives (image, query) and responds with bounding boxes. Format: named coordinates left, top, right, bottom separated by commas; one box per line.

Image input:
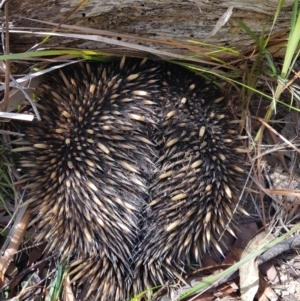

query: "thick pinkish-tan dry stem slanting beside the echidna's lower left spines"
left=0, top=210, right=30, bottom=284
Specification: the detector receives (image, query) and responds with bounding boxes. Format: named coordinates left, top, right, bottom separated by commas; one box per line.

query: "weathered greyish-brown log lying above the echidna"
left=1, top=0, right=294, bottom=55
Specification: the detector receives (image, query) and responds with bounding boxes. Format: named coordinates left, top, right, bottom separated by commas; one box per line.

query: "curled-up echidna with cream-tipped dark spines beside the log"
left=15, top=59, right=243, bottom=300
